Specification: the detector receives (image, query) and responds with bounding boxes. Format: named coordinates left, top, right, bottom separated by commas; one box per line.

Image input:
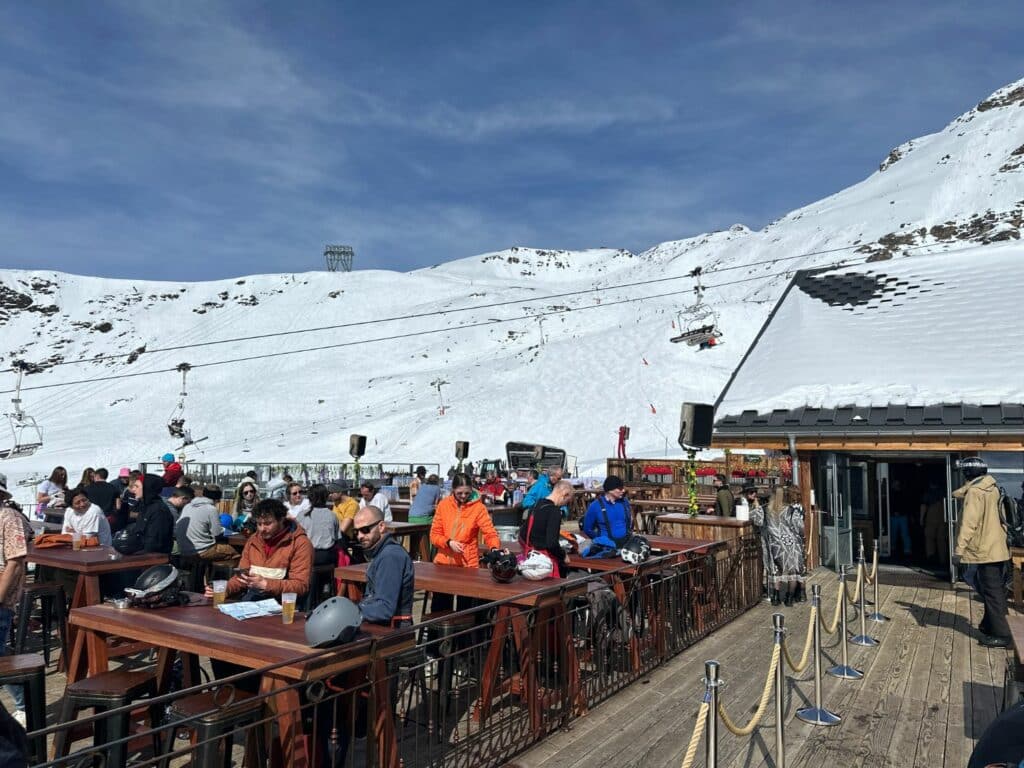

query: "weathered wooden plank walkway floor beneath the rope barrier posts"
left=508, top=570, right=1012, bottom=768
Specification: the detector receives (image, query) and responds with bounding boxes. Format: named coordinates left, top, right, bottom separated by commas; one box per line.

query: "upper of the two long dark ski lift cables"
left=18, top=244, right=888, bottom=369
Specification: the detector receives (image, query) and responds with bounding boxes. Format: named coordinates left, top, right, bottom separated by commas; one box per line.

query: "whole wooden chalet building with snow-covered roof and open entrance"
left=714, top=244, right=1024, bottom=578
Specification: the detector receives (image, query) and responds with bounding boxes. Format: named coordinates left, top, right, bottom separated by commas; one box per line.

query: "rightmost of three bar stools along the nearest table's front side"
left=160, top=688, right=267, bottom=768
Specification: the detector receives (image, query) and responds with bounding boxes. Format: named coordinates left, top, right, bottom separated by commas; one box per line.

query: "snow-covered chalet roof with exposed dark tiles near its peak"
left=717, top=243, right=1024, bottom=431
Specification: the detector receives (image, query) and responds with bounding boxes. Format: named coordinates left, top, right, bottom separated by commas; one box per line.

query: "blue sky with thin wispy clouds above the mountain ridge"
left=0, top=0, right=1024, bottom=280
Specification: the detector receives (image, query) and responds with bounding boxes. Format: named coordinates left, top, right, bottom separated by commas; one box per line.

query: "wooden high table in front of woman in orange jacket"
left=334, top=561, right=587, bottom=735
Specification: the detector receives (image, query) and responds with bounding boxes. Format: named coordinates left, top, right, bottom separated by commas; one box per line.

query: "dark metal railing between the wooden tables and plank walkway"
left=32, top=536, right=762, bottom=768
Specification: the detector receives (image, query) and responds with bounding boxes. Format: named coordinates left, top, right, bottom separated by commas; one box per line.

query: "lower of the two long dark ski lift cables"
left=0, top=244, right=976, bottom=394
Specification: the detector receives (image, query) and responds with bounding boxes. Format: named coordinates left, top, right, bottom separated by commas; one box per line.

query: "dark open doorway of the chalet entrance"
left=877, top=459, right=949, bottom=573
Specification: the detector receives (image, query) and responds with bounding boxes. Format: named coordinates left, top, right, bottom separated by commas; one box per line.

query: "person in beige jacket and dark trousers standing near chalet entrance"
left=953, top=457, right=1013, bottom=648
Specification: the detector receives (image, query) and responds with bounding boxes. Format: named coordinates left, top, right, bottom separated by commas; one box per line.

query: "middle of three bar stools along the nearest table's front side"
left=53, top=668, right=163, bottom=766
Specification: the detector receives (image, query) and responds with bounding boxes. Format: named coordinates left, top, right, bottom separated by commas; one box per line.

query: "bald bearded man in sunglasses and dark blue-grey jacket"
left=352, top=505, right=414, bottom=627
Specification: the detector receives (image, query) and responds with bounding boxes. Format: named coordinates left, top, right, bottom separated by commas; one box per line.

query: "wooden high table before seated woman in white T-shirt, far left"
left=28, top=544, right=170, bottom=674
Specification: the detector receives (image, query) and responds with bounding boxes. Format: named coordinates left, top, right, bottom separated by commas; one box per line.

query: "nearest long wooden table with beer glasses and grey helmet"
left=68, top=599, right=414, bottom=768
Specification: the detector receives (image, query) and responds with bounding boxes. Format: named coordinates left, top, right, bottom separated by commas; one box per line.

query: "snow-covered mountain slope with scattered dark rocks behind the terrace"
left=0, top=80, right=1024, bottom=487
